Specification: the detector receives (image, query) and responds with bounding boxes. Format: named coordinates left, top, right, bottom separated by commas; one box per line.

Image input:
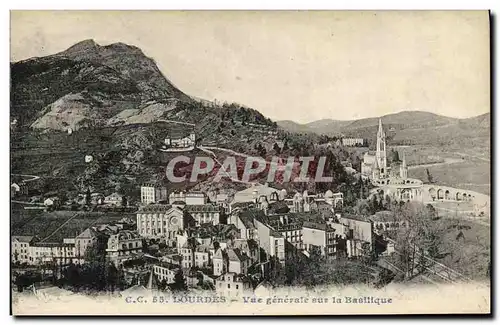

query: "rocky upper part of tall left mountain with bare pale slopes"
left=11, top=40, right=191, bottom=130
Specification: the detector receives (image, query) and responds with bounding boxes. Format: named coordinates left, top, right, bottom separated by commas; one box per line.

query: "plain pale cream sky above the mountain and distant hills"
left=11, top=11, right=490, bottom=123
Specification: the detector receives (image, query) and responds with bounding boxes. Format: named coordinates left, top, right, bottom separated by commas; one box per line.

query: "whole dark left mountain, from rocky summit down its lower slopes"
left=10, top=40, right=286, bottom=192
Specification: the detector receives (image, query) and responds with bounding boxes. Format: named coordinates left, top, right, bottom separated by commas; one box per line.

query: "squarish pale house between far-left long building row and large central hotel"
left=106, top=230, right=142, bottom=265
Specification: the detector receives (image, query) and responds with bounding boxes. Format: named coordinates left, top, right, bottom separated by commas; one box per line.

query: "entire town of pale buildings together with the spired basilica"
left=11, top=122, right=489, bottom=299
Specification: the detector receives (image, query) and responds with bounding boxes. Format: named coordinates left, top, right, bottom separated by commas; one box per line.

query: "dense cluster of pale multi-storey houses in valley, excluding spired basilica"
left=12, top=183, right=396, bottom=297
